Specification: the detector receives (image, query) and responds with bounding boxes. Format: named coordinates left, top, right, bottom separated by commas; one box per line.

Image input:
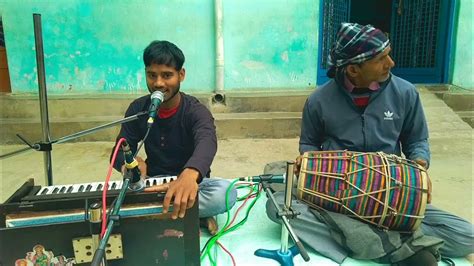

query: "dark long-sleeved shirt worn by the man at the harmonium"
left=112, top=93, right=217, bottom=179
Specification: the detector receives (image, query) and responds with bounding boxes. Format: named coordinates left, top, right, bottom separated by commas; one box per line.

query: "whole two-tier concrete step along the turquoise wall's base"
left=0, top=86, right=472, bottom=143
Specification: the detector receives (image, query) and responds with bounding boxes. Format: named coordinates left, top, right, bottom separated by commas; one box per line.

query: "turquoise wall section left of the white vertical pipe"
left=0, top=0, right=214, bottom=94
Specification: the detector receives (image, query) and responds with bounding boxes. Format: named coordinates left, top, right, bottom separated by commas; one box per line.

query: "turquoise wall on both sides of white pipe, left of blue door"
left=0, top=0, right=319, bottom=94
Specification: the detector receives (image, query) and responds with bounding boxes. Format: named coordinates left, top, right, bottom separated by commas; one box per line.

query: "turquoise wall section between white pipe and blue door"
left=224, top=0, right=319, bottom=89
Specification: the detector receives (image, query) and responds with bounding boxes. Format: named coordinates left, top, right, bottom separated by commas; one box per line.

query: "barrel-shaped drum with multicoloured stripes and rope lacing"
left=297, top=151, right=429, bottom=231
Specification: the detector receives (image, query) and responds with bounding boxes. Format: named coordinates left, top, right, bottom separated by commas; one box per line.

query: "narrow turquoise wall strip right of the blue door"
left=452, top=0, right=474, bottom=90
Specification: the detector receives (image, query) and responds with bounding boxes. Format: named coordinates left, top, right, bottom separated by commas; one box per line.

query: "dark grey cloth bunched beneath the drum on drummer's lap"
left=310, top=209, right=443, bottom=263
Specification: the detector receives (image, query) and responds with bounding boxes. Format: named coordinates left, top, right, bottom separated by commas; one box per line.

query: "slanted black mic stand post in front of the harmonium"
left=91, top=175, right=131, bottom=266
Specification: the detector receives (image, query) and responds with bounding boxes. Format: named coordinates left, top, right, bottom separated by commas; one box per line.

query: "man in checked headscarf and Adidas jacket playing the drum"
left=267, top=23, right=474, bottom=265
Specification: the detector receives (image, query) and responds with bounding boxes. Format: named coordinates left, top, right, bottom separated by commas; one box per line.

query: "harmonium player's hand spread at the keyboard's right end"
left=145, top=168, right=199, bottom=219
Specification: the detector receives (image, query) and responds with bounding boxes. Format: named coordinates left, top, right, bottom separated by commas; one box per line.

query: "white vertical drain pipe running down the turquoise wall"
left=212, top=0, right=225, bottom=104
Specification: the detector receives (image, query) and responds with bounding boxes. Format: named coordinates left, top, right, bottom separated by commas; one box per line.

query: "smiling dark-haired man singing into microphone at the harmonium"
left=114, top=41, right=237, bottom=234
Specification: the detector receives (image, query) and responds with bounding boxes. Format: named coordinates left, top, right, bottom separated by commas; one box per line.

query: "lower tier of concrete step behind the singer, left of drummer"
left=0, top=112, right=301, bottom=144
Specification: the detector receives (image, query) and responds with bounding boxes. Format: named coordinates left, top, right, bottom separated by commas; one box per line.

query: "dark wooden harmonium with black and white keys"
left=0, top=177, right=199, bottom=266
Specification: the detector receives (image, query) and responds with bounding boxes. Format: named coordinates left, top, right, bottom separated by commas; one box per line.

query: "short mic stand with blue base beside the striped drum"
left=254, top=162, right=309, bottom=266
